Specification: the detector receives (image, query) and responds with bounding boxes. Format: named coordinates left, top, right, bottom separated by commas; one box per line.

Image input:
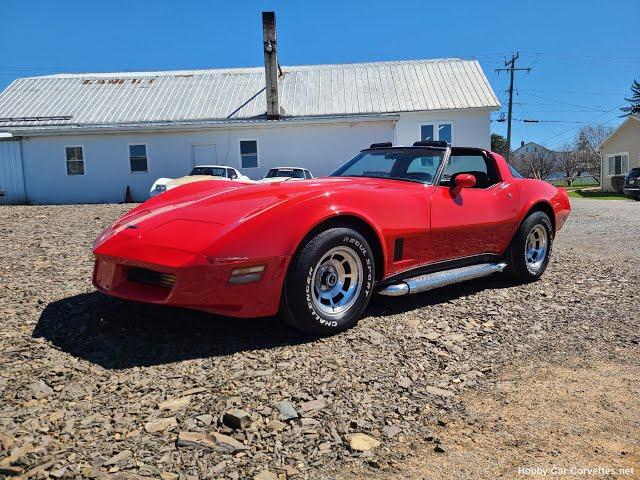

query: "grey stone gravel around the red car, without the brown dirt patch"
left=0, top=200, right=640, bottom=480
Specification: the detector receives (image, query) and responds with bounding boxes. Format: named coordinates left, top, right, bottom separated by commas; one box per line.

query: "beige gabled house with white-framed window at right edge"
left=598, top=115, right=640, bottom=191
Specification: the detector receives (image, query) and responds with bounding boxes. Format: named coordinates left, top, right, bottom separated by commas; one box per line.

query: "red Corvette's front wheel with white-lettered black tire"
left=280, top=228, right=375, bottom=335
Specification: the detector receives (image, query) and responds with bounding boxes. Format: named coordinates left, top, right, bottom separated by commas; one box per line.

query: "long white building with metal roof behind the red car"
left=0, top=59, right=499, bottom=203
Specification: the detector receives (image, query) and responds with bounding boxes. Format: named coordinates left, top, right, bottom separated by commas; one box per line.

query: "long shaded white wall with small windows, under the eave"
left=23, top=120, right=393, bottom=203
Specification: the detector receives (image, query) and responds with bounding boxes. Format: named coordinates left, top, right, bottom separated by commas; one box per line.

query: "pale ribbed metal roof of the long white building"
left=0, top=59, right=500, bottom=131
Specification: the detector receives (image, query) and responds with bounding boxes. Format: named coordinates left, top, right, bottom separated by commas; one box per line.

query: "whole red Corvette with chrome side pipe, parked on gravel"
left=93, top=142, right=570, bottom=334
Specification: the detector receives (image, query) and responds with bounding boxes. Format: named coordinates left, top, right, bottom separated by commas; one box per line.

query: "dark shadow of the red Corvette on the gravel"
left=33, top=279, right=509, bottom=369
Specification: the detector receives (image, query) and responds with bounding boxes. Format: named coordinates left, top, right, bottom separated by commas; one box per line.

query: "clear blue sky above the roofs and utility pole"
left=0, top=0, right=640, bottom=147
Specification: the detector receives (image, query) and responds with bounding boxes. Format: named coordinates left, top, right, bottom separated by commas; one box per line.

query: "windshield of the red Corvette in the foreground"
left=330, top=147, right=445, bottom=184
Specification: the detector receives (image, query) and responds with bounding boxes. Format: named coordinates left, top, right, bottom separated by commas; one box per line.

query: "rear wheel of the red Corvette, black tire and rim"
left=508, top=211, right=553, bottom=282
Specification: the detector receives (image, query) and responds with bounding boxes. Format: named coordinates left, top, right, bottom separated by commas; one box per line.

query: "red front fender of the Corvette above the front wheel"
left=206, top=184, right=429, bottom=276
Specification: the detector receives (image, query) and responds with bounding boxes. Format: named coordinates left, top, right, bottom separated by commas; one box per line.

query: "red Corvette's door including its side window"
left=429, top=148, right=518, bottom=262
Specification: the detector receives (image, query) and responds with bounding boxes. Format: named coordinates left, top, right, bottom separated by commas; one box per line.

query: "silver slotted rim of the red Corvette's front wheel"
left=311, top=247, right=364, bottom=318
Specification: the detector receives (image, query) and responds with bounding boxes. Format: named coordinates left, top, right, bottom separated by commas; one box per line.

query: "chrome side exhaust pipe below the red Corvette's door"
left=378, top=263, right=507, bottom=297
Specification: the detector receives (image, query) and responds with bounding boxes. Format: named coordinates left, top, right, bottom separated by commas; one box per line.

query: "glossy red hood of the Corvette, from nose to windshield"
left=94, top=177, right=424, bottom=254
